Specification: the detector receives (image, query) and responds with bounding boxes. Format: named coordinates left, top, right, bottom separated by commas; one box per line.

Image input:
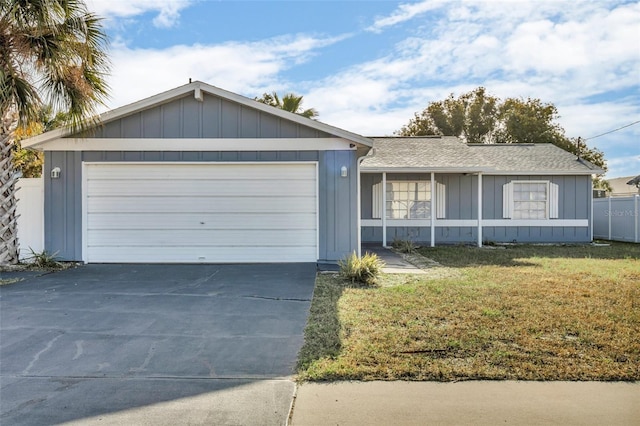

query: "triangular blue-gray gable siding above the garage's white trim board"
left=76, top=94, right=331, bottom=138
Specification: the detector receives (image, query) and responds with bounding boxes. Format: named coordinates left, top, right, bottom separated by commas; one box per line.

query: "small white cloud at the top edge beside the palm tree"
left=87, top=0, right=193, bottom=28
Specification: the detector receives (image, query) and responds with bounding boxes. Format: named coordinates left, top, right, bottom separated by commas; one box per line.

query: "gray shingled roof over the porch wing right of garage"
left=362, top=136, right=602, bottom=174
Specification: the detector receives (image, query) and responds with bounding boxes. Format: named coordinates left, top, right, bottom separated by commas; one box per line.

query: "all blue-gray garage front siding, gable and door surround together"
left=44, top=92, right=366, bottom=262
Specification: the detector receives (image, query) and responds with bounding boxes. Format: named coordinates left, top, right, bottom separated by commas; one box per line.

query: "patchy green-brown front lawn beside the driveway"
left=298, top=243, right=640, bottom=381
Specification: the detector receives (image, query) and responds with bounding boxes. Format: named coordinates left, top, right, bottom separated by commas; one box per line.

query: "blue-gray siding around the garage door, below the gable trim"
left=44, top=151, right=357, bottom=262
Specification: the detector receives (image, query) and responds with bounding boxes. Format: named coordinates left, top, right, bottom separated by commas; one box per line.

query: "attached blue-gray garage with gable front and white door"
left=23, top=82, right=373, bottom=263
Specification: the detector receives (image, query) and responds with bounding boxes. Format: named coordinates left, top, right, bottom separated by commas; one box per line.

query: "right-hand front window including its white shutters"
left=503, top=181, right=558, bottom=220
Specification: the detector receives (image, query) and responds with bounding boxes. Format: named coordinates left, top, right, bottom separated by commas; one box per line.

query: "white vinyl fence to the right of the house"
left=593, top=195, right=640, bottom=243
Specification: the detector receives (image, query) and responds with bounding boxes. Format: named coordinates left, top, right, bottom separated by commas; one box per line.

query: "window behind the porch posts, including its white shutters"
left=372, top=180, right=446, bottom=219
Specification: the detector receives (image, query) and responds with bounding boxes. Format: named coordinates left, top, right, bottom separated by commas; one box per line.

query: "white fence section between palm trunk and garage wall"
left=16, top=178, right=44, bottom=259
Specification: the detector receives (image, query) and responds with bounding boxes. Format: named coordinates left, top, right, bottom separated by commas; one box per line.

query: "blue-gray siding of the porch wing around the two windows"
left=361, top=173, right=591, bottom=244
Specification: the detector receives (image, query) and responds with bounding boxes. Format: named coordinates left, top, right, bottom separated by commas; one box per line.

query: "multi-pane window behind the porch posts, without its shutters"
left=386, top=181, right=431, bottom=219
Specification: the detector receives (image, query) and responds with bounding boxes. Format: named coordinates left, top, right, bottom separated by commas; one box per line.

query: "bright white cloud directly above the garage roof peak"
left=104, top=34, right=345, bottom=107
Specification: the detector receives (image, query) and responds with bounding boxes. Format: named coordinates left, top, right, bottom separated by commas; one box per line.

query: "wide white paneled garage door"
left=83, top=163, right=318, bottom=263
